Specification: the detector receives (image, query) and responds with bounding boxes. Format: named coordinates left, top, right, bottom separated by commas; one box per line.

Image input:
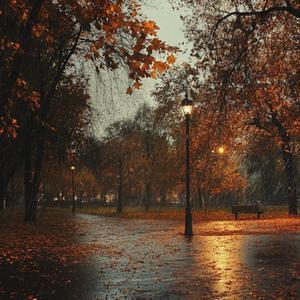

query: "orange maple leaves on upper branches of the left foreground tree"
left=0, top=0, right=177, bottom=134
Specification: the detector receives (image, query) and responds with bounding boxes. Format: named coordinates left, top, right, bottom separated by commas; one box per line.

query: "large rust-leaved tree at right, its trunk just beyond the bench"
left=178, top=0, right=300, bottom=214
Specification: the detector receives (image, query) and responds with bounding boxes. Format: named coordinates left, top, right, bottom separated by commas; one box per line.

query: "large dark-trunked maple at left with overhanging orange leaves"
left=0, top=0, right=176, bottom=221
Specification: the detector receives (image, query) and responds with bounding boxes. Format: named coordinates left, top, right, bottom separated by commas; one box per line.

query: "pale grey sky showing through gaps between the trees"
left=91, top=0, right=188, bottom=136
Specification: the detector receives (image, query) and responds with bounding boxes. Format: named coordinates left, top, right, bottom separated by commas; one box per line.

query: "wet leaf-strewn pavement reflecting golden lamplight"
left=1, top=214, right=300, bottom=299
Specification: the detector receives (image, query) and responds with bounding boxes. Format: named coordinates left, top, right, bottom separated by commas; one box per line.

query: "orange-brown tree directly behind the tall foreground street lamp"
left=154, top=64, right=246, bottom=207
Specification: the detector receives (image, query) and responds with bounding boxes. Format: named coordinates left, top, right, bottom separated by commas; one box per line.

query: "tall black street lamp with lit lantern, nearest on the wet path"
left=181, top=93, right=193, bottom=236
